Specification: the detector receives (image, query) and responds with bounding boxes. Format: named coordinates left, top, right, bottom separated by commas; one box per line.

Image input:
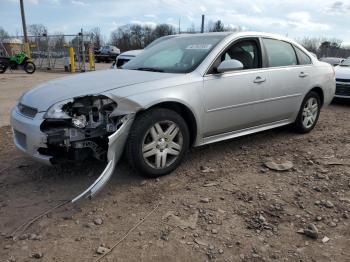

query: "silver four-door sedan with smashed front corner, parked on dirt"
left=11, top=32, right=335, bottom=201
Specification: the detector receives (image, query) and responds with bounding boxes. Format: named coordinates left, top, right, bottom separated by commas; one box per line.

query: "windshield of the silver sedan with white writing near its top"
left=122, top=35, right=225, bottom=73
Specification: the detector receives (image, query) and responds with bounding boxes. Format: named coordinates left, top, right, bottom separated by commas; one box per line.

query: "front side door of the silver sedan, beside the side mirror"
left=203, top=38, right=270, bottom=139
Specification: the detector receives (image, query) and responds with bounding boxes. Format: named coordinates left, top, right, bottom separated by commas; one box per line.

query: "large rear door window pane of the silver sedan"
left=263, top=38, right=298, bottom=67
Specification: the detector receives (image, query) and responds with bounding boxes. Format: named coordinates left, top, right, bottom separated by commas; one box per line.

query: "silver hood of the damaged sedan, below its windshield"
left=20, top=69, right=176, bottom=112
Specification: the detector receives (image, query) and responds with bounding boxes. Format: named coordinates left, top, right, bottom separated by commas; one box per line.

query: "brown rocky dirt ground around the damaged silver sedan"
left=0, top=70, right=350, bottom=262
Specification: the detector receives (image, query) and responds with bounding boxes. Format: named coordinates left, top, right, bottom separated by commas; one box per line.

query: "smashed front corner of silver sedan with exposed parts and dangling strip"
left=39, top=95, right=136, bottom=202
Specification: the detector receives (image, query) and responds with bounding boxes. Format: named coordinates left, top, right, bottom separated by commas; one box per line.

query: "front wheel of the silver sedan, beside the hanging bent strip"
left=126, top=108, right=190, bottom=178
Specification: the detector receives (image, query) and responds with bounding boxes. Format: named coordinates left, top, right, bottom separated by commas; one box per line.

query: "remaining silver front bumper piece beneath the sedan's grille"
left=11, top=106, right=52, bottom=165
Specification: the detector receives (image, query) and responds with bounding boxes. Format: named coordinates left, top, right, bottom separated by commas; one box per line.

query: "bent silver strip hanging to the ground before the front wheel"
left=71, top=113, right=135, bottom=203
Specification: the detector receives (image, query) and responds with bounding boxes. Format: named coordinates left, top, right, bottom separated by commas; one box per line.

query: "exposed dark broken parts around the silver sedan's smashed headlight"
left=39, top=95, right=121, bottom=162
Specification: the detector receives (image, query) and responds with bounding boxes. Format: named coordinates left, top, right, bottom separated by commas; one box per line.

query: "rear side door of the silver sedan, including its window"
left=262, top=38, right=312, bottom=122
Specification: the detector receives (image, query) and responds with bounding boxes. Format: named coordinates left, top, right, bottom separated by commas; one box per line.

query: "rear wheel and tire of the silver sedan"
left=294, top=91, right=321, bottom=134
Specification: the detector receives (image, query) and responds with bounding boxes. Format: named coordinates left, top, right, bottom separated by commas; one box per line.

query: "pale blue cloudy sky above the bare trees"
left=0, top=0, right=350, bottom=45
